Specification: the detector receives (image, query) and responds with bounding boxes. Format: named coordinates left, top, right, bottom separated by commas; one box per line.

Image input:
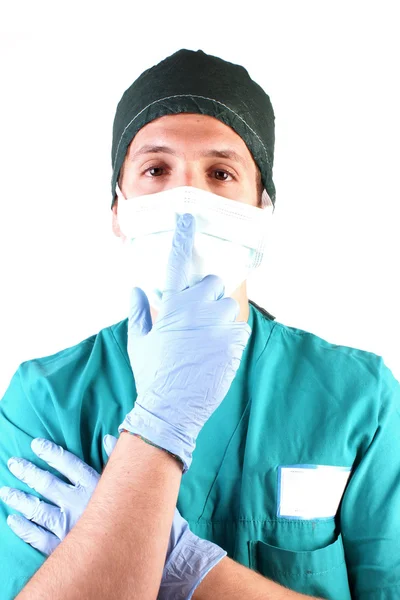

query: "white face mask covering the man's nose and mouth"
left=116, top=185, right=273, bottom=311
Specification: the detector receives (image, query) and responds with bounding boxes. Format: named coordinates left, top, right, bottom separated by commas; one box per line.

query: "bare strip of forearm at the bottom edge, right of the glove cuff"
left=193, top=557, right=322, bottom=600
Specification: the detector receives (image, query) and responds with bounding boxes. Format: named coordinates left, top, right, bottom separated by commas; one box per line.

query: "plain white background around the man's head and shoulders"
left=0, top=0, right=400, bottom=397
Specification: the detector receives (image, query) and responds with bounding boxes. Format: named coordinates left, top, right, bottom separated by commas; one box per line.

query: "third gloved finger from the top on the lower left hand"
left=1, top=487, right=65, bottom=539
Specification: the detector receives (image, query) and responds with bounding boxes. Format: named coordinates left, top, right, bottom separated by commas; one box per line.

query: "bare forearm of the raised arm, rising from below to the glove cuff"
left=17, top=433, right=182, bottom=600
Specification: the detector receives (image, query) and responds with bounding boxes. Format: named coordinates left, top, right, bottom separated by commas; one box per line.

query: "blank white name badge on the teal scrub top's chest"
left=277, top=465, right=351, bottom=519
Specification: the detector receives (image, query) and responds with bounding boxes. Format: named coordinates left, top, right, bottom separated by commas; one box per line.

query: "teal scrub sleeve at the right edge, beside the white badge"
left=340, top=360, right=400, bottom=600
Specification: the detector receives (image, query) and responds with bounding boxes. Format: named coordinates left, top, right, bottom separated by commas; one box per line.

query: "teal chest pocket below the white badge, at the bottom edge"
left=248, top=535, right=351, bottom=600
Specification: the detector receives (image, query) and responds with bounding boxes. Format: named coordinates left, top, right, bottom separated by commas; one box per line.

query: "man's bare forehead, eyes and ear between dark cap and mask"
left=112, top=113, right=261, bottom=237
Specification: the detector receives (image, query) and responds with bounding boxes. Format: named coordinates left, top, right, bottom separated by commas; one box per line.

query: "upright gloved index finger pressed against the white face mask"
left=163, top=213, right=196, bottom=302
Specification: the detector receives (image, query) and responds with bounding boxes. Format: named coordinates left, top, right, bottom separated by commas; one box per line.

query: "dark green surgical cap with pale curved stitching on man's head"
left=111, top=49, right=276, bottom=206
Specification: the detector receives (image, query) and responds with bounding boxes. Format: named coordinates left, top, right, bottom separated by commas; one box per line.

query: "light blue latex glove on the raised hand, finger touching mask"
left=120, top=214, right=251, bottom=472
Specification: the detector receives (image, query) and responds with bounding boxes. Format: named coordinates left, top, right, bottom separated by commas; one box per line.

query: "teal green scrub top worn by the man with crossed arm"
left=0, top=303, right=400, bottom=600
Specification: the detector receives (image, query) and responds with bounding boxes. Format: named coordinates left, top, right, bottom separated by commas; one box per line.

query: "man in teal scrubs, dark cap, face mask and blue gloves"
left=0, top=49, right=400, bottom=600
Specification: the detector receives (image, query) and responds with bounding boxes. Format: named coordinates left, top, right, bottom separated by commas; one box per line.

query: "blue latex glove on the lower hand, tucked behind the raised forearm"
left=0, top=435, right=226, bottom=600
